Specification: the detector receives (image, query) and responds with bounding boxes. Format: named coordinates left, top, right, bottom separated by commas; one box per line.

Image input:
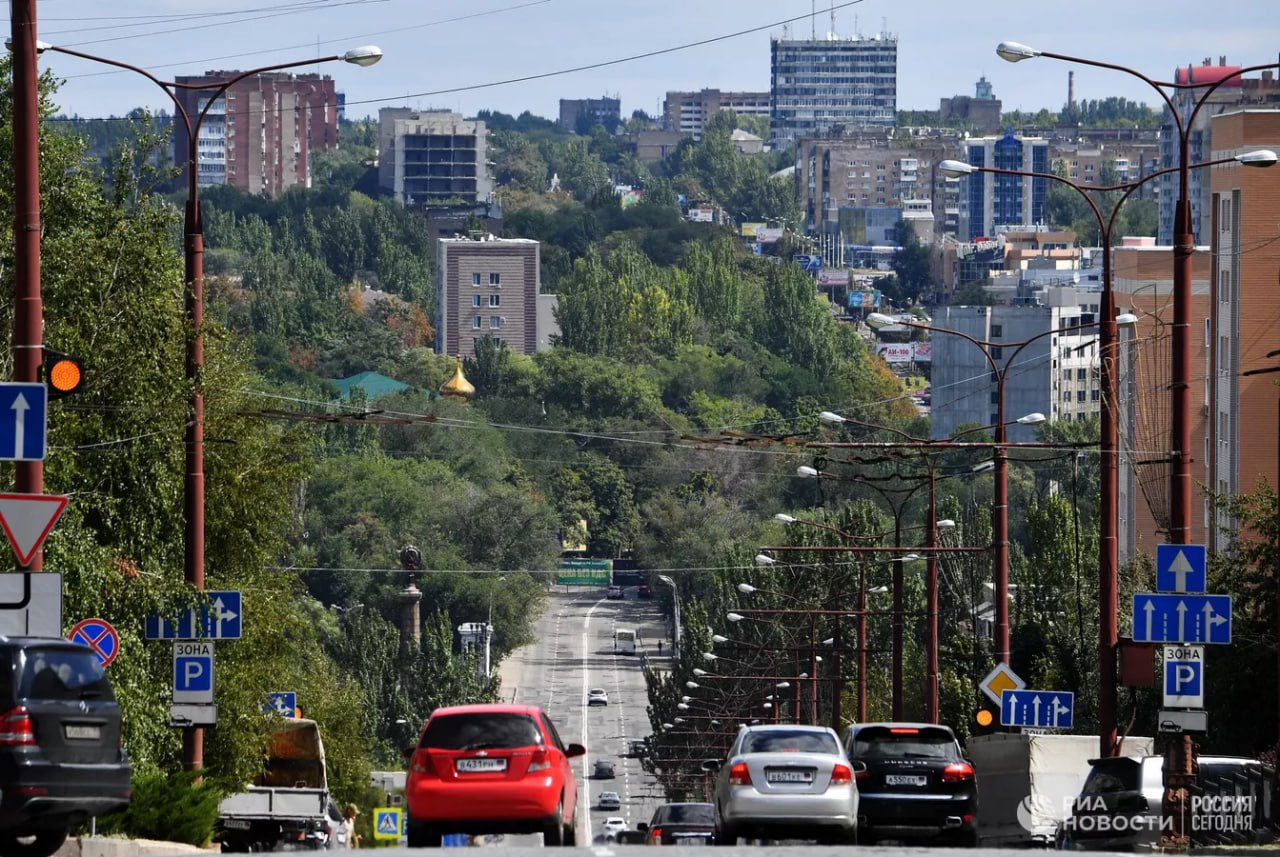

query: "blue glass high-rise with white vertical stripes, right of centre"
left=959, top=132, right=1050, bottom=240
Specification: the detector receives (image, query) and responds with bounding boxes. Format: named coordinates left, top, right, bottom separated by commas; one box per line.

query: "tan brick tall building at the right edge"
left=1193, top=110, right=1280, bottom=557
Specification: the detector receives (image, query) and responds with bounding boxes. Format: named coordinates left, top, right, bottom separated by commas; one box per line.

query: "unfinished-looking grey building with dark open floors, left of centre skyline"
left=378, top=107, right=493, bottom=208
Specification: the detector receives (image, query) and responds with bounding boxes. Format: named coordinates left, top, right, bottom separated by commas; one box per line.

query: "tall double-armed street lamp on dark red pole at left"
left=36, top=42, right=383, bottom=770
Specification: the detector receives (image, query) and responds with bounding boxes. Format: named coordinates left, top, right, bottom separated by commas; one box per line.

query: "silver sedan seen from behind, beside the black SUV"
left=703, top=724, right=858, bottom=844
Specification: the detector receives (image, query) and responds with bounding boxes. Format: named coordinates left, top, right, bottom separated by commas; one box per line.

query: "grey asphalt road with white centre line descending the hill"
left=499, top=587, right=669, bottom=847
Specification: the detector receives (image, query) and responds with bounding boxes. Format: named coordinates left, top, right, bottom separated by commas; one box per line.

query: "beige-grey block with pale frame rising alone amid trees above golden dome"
left=435, top=234, right=540, bottom=357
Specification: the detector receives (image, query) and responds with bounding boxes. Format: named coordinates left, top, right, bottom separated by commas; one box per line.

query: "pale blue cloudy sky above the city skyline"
left=17, top=0, right=1280, bottom=124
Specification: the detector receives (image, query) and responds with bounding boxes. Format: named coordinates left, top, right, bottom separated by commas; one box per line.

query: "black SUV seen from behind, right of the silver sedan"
left=845, top=723, right=978, bottom=848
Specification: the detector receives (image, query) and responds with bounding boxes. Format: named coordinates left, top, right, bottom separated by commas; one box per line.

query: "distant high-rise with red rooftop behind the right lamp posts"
left=1156, top=56, right=1280, bottom=246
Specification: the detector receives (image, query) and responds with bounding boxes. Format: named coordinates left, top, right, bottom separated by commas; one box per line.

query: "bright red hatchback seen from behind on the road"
left=404, top=705, right=586, bottom=848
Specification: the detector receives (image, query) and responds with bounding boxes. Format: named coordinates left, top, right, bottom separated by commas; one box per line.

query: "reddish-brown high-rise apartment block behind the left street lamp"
left=173, top=72, right=340, bottom=197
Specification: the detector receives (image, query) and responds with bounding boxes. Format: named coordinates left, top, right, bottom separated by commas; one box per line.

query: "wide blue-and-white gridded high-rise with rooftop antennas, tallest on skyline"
left=769, top=33, right=897, bottom=147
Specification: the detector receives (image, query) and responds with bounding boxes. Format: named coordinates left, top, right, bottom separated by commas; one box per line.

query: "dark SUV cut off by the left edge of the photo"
left=0, top=636, right=132, bottom=857
